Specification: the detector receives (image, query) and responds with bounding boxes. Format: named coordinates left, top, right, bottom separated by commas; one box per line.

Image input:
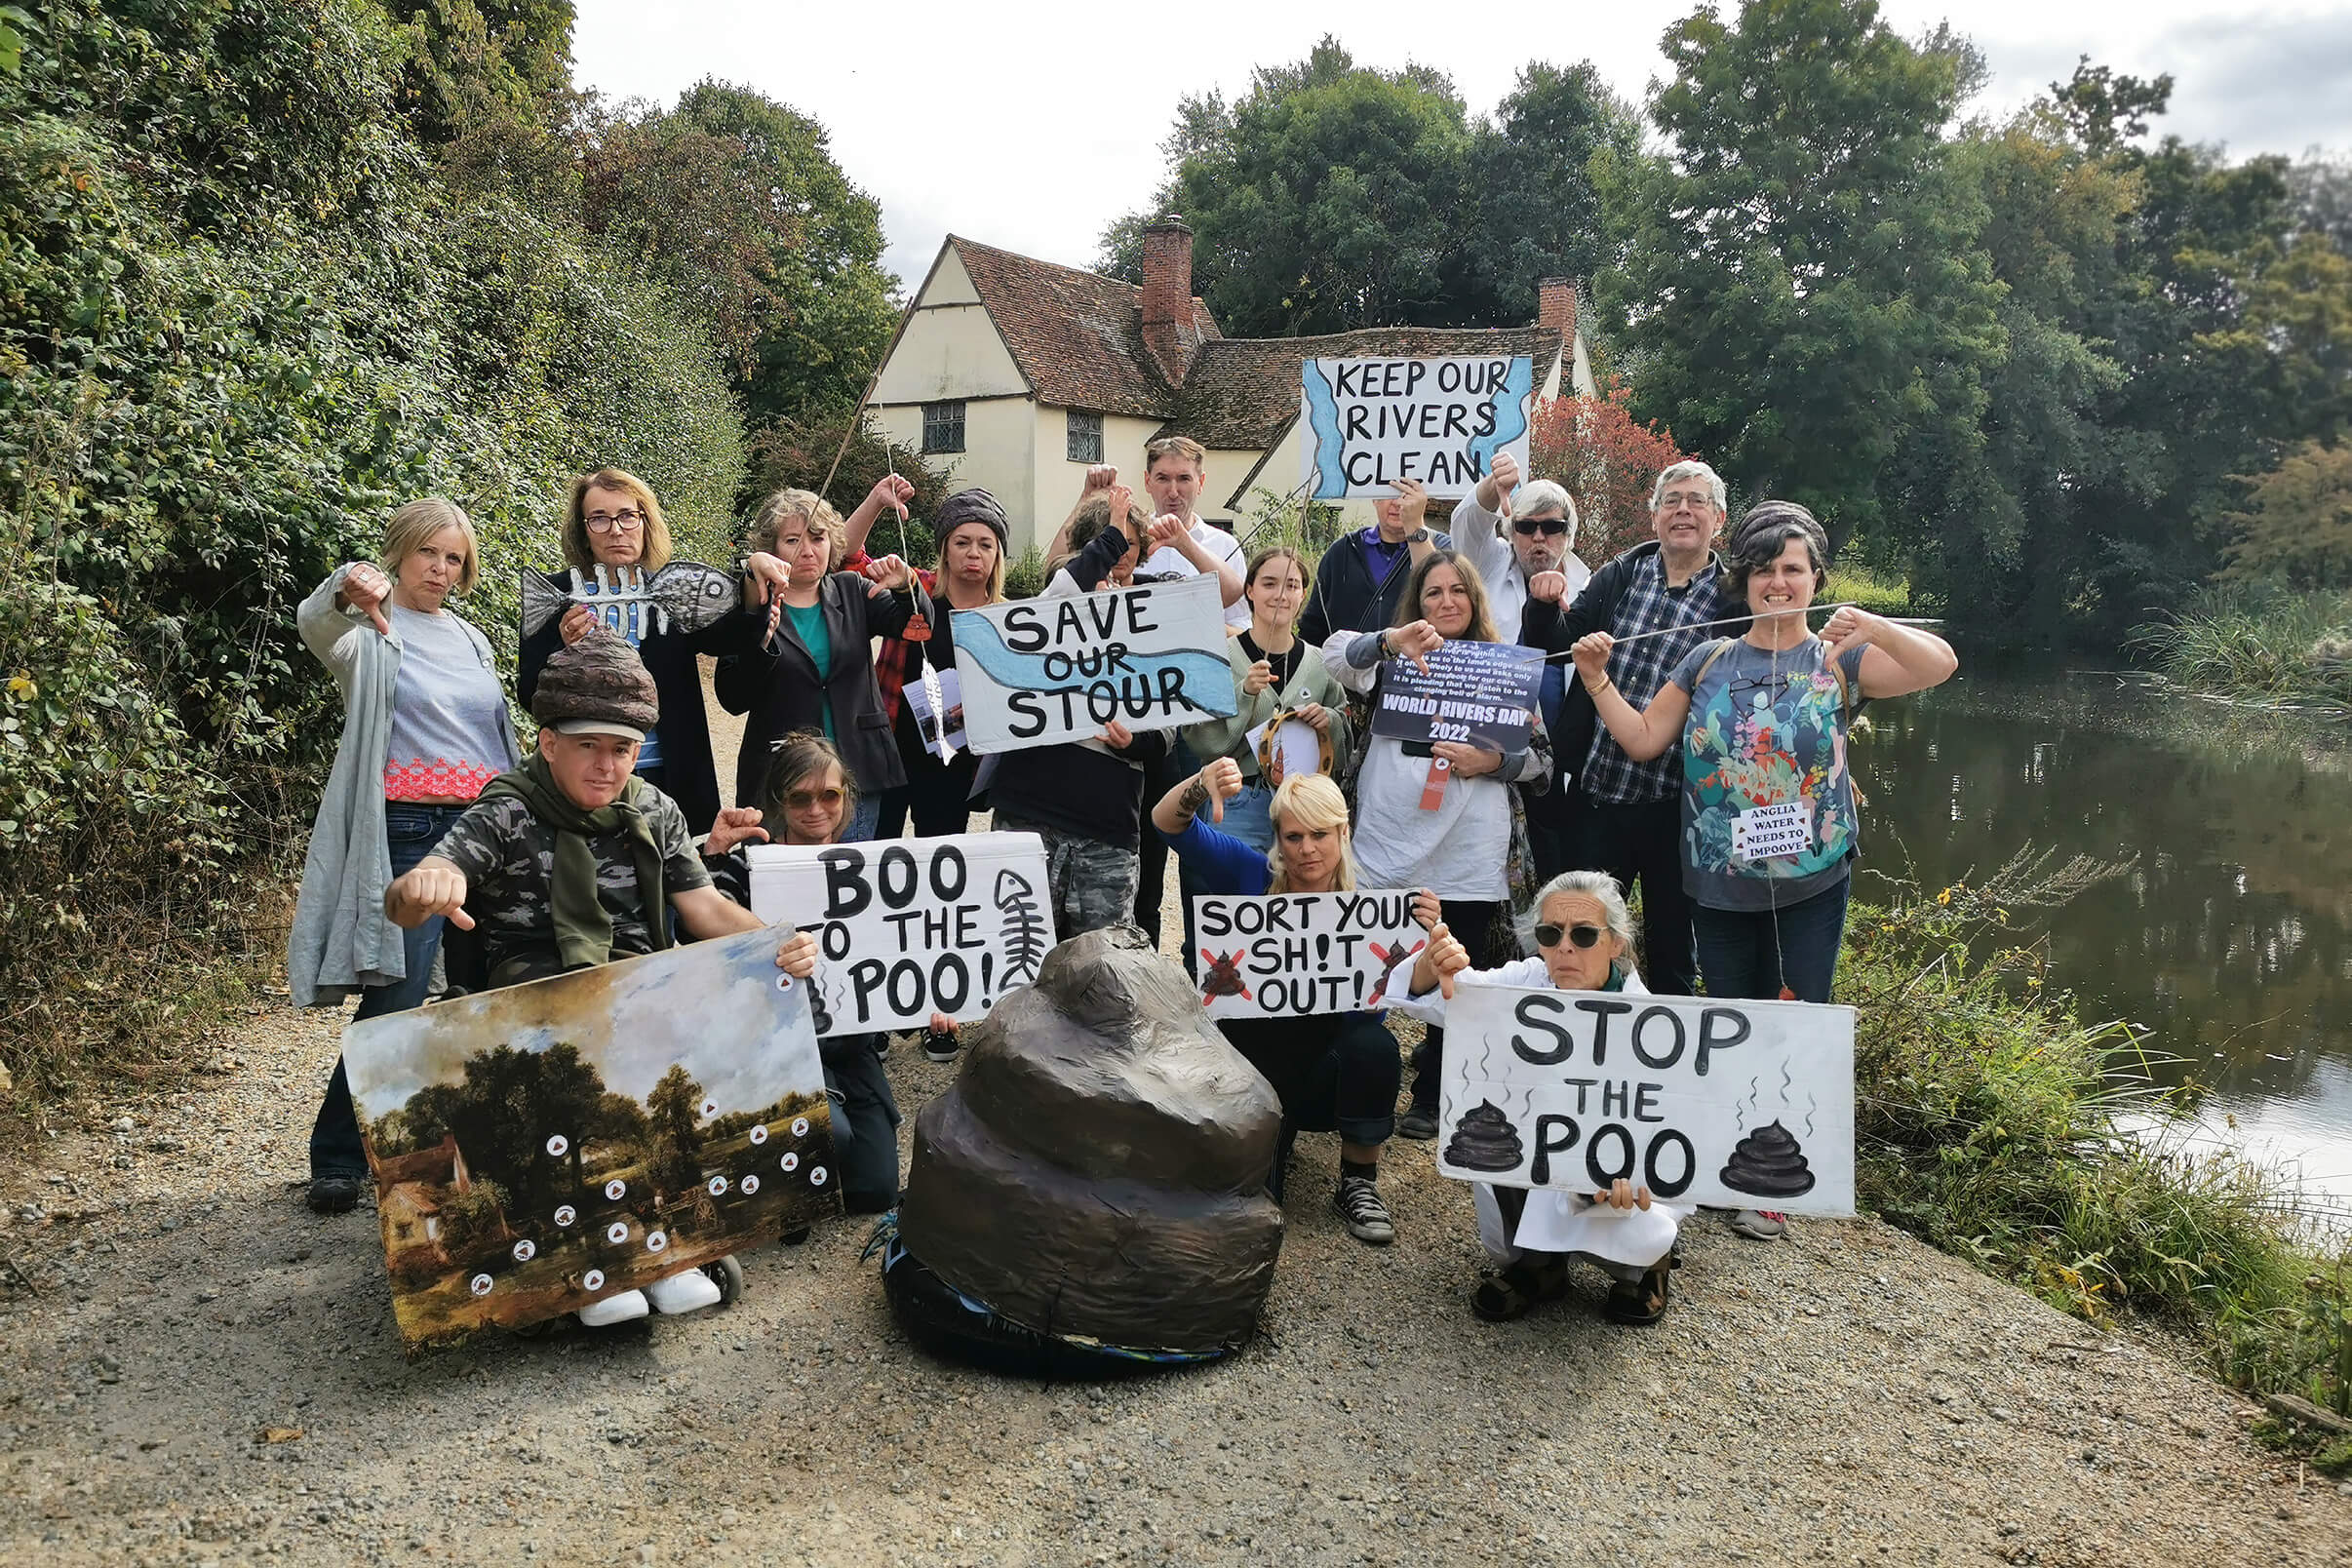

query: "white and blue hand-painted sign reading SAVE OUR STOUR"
left=955, top=576, right=1239, bottom=755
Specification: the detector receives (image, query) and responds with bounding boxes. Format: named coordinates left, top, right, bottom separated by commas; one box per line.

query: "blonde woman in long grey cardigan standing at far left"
left=287, top=496, right=522, bottom=1213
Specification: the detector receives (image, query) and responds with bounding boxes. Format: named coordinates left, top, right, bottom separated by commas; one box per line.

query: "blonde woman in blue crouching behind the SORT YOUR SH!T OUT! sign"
left=1153, top=757, right=1434, bottom=1246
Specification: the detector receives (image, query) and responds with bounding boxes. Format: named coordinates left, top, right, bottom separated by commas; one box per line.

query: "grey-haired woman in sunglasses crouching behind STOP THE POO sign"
left=1390, top=872, right=1689, bottom=1323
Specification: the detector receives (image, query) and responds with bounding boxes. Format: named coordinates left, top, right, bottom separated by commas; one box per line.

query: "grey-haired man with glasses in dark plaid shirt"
left=1519, top=461, right=1741, bottom=997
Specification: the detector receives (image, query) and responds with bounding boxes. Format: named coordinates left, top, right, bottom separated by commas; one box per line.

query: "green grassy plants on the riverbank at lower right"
left=1839, top=856, right=2342, bottom=1401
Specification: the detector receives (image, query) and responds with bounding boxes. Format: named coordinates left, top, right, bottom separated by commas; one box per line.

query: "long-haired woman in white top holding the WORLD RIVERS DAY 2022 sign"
left=1324, top=550, right=1552, bottom=1138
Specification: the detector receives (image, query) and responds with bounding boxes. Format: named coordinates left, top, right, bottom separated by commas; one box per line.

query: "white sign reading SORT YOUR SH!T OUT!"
left=1193, top=891, right=1428, bottom=1018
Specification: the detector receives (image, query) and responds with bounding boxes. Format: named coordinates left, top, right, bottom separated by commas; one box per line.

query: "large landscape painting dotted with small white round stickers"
left=343, top=931, right=840, bottom=1345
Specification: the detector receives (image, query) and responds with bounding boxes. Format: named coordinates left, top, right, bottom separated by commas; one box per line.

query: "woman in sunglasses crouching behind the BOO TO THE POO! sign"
left=703, top=728, right=935, bottom=1213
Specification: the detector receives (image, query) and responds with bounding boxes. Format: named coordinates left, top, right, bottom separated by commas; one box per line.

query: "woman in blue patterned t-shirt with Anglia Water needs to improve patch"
left=1574, top=500, right=1959, bottom=1241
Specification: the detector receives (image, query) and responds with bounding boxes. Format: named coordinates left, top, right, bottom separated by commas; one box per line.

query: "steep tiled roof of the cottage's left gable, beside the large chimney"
left=948, top=235, right=1223, bottom=418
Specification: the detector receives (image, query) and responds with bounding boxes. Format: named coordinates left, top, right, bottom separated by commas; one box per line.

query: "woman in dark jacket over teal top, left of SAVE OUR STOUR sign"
left=713, top=489, right=931, bottom=842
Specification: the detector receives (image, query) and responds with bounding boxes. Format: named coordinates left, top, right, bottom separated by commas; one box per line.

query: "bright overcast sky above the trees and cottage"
left=571, top=0, right=2352, bottom=290
